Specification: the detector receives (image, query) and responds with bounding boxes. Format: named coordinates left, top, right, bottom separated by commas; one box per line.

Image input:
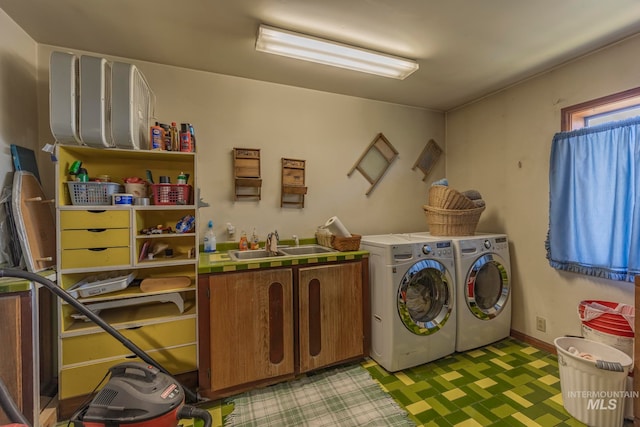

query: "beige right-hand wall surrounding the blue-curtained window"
left=446, top=37, right=640, bottom=343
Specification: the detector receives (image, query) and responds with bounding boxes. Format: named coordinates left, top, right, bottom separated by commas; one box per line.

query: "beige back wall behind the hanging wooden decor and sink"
left=39, top=46, right=445, bottom=242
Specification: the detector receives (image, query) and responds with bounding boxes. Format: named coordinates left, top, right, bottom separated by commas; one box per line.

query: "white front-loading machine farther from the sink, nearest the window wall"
left=411, top=233, right=511, bottom=351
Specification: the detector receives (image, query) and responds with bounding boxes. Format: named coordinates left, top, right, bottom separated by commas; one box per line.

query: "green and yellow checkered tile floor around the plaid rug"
left=58, top=338, right=632, bottom=427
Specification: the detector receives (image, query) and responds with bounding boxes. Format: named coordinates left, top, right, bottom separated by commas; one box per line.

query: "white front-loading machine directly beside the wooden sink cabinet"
left=361, top=234, right=456, bottom=372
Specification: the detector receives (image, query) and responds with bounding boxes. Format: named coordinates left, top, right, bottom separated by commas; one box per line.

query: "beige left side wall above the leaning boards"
left=0, top=9, right=38, bottom=265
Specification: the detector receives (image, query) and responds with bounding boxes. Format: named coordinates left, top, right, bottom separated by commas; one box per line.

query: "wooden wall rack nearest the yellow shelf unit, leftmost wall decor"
left=233, top=148, right=262, bottom=200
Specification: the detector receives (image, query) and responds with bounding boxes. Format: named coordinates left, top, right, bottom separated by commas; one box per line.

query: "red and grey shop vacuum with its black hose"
left=0, top=269, right=212, bottom=427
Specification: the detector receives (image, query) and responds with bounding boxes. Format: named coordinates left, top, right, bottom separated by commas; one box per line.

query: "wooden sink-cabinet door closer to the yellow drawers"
left=209, top=269, right=294, bottom=391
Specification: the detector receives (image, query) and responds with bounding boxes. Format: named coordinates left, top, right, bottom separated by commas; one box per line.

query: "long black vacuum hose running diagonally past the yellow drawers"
left=0, top=268, right=198, bottom=403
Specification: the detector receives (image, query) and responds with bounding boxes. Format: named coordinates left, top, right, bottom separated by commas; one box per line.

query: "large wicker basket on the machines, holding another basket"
left=423, top=205, right=485, bottom=236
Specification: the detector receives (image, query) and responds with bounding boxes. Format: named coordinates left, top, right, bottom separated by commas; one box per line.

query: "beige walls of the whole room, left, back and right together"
left=0, top=10, right=640, bottom=348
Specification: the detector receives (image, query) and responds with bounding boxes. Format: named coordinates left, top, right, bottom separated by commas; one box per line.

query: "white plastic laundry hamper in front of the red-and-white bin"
left=554, top=337, right=632, bottom=427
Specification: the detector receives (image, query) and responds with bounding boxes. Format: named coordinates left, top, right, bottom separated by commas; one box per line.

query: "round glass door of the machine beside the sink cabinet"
left=397, top=259, right=453, bottom=335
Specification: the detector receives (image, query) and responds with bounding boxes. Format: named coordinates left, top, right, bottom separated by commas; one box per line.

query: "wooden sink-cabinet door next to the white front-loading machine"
left=298, top=262, right=364, bottom=372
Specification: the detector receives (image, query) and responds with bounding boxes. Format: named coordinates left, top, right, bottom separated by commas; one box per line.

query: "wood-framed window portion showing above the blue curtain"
left=560, top=88, right=640, bottom=131
